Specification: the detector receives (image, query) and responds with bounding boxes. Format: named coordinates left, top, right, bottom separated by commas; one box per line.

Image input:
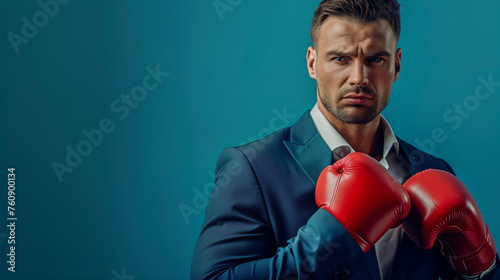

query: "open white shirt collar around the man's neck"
left=311, top=103, right=399, bottom=158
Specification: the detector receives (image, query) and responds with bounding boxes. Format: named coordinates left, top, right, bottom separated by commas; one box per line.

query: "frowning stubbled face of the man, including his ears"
left=307, top=16, right=401, bottom=124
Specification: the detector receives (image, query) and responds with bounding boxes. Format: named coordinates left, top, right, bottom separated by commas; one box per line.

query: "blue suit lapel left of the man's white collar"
left=283, top=110, right=333, bottom=185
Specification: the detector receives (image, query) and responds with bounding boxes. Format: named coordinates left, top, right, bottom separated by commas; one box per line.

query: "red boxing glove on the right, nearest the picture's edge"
left=403, top=169, right=497, bottom=275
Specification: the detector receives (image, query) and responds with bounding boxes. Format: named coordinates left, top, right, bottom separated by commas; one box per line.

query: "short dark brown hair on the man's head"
left=310, top=0, right=401, bottom=46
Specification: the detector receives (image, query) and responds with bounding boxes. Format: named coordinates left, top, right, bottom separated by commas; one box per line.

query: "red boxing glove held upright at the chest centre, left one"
left=316, top=153, right=411, bottom=253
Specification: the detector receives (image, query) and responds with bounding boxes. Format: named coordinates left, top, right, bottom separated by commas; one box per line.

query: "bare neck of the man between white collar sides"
left=318, top=104, right=384, bottom=160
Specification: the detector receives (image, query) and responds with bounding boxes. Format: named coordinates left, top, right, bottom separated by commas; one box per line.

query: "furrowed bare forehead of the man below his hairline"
left=318, top=16, right=397, bottom=47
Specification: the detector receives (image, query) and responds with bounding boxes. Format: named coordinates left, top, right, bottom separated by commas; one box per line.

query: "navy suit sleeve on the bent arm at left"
left=191, top=148, right=368, bottom=280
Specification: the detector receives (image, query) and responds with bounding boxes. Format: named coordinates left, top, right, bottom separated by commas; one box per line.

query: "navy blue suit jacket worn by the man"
left=191, top=111, right=496, bottom=280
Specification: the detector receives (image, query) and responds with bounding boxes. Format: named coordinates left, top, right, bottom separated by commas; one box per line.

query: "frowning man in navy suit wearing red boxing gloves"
left=191, top=0, right=500, bottom=279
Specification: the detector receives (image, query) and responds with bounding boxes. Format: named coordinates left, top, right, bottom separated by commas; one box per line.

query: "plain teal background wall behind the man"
left=0, top=0, right=500, bottom=280
